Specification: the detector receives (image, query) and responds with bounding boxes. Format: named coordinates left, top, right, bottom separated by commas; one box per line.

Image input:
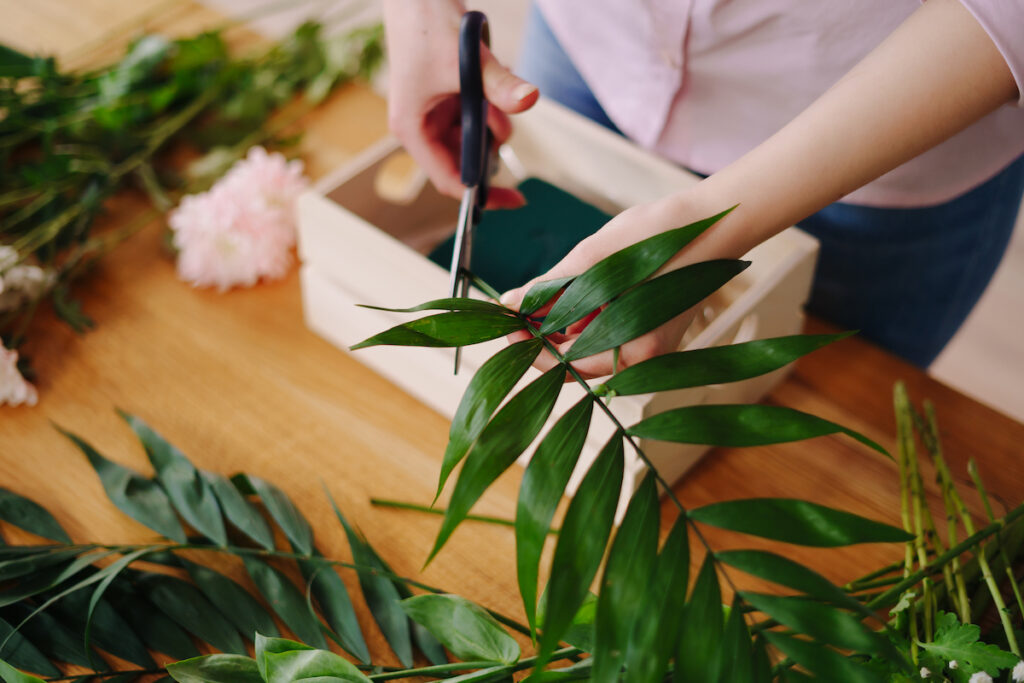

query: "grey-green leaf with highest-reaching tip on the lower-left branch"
left=119, top=411, right=227, bottom=546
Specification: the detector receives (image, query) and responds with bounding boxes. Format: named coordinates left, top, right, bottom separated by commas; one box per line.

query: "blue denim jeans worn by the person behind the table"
left=517, top=6, right=1024, bottom=368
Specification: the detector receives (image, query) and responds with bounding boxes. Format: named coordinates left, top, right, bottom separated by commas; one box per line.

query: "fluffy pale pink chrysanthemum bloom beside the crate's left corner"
left=168, top=147, right=306, bottom=292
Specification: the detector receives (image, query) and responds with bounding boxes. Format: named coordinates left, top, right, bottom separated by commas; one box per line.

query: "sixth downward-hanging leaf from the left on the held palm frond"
left=626, top=514, right=690, bottom=683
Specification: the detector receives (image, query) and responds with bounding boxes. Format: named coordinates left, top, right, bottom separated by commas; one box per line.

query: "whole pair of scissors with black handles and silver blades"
left=450, top=11, right=494, bottom=375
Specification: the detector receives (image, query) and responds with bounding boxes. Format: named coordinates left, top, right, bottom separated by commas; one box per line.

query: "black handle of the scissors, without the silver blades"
left=459, top=11, right=490, bottom=187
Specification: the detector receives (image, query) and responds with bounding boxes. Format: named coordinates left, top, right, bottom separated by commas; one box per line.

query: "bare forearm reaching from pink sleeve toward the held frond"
left=665, top=0, right=1017, bottom=260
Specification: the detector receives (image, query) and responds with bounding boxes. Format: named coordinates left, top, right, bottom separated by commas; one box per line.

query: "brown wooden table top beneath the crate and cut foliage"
left=0, top=0, right=1024, bottom=671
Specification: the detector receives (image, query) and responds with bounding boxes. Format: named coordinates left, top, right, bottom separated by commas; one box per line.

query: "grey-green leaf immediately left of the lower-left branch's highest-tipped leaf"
left=57, top=427, right=185, bottom=543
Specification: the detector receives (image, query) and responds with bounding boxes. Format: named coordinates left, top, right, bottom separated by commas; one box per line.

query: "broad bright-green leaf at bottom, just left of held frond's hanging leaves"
left=401, top=595, right=519, bottom=664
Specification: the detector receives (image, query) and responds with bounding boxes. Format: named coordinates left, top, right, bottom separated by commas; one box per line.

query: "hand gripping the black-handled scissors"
left=384, top=0, right=539, bottom=208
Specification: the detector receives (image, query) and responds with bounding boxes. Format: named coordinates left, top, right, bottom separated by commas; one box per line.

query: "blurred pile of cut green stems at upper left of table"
left=0, top=10, right=382, bottom=370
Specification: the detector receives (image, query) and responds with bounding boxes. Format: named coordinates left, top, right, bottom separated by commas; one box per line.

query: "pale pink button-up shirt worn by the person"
left=538, top=0, right=1024, bottom=207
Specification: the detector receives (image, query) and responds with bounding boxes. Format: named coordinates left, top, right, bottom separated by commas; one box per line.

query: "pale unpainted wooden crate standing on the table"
left=299, top=99, right=817, bottom=509
